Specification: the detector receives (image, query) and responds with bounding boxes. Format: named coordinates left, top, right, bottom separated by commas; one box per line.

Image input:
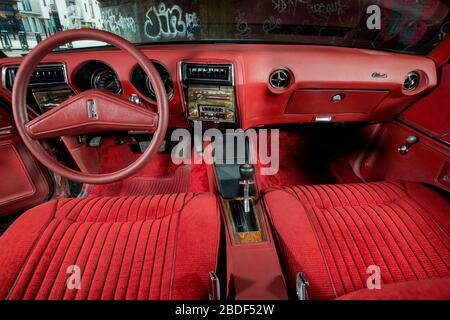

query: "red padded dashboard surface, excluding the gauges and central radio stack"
left=0, top=44, right=437, bottom=129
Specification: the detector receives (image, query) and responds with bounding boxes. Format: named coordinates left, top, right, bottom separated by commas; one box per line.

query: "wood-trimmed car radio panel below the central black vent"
left=187, top=85, right=235, bottom=123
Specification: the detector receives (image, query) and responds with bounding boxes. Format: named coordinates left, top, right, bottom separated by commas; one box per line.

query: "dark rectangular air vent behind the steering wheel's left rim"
left=3, top=65, right=67, bottom=90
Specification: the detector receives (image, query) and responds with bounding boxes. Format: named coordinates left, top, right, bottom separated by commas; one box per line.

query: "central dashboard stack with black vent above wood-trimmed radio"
left=180, top=62, right=236, bottom=124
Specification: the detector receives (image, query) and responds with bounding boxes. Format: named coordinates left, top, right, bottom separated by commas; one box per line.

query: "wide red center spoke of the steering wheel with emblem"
left=25, top=90, right=158, bottom=139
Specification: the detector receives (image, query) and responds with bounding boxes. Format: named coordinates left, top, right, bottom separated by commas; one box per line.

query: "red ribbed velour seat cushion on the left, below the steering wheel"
left=0, top=194, right=220, bottom=299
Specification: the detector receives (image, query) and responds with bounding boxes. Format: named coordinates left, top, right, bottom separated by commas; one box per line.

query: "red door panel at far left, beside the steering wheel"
left=0, top=109, right=51, bottom=216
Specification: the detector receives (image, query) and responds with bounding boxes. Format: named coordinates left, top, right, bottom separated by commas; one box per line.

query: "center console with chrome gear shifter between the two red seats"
left=211, top=130, right=288, bottom=300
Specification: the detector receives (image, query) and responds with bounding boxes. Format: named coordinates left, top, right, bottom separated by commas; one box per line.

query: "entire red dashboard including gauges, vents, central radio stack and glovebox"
left=0, top=44, right=437, bottom=129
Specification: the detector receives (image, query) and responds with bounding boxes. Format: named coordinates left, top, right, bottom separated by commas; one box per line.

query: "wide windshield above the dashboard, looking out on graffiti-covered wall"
left=0, top=0, right=450, bottom=56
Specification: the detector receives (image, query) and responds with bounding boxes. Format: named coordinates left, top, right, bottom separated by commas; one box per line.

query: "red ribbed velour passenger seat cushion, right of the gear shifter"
left=264, top=182, right=450, bottom=299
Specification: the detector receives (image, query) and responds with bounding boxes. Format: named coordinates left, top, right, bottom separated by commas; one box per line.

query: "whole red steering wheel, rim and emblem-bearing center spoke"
left=12, top=29, right=169, bottom=184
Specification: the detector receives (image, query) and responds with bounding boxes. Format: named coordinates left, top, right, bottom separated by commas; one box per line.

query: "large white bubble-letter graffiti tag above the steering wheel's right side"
left=144, top=3, right=200, bottom=40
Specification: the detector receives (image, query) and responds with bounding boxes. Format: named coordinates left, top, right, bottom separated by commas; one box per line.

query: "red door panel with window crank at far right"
left=361, top=64, right=450, bottom=191
